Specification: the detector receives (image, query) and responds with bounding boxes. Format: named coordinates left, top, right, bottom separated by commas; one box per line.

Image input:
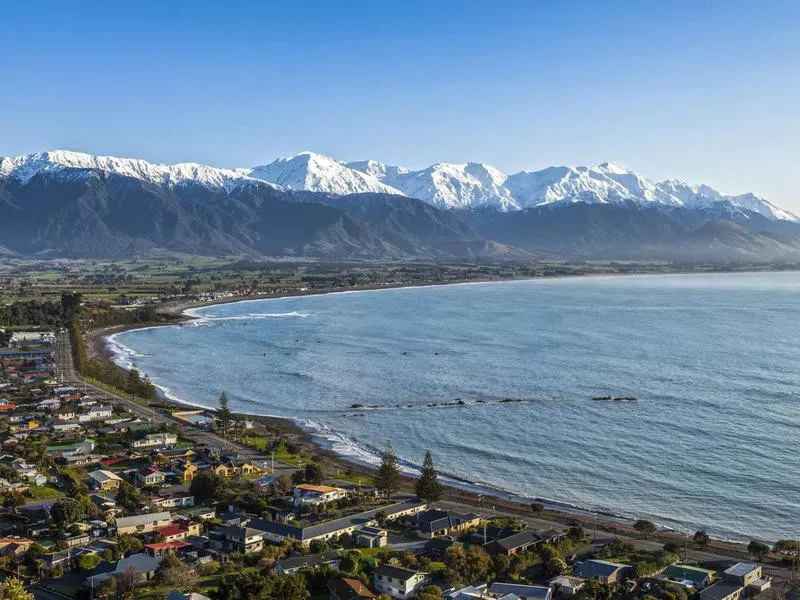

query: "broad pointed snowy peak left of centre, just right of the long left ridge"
left=248, top=152, right=402, bottom=196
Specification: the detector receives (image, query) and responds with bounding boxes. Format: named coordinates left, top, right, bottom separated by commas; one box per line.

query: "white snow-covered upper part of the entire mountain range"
left=0, top=150, right=800, bottom=222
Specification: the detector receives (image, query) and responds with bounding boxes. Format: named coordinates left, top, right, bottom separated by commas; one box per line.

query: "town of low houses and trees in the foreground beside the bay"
left=0, top=310, right=800, bottom=600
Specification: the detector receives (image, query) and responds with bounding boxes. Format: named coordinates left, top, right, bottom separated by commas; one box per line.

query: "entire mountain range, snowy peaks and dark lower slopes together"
left=0, top=151, right=800, bottom=261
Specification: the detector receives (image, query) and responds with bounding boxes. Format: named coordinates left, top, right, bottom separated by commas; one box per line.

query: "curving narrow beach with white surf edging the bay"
left=85, top=272, right=784, bottom=558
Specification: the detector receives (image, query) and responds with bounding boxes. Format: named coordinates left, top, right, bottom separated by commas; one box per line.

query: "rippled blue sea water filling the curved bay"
left=109, top=272, right=800, bottom=541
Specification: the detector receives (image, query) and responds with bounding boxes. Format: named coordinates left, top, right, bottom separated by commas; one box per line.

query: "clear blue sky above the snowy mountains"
left=0, top=0, right=800, bottom=210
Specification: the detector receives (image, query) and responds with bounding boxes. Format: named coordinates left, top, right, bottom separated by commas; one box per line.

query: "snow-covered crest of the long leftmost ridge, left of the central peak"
left=0, top=150, right=266, bottom=190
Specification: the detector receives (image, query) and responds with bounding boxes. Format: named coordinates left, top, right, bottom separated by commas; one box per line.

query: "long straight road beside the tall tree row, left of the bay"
left=55, top=331, right=297, bottom=476
